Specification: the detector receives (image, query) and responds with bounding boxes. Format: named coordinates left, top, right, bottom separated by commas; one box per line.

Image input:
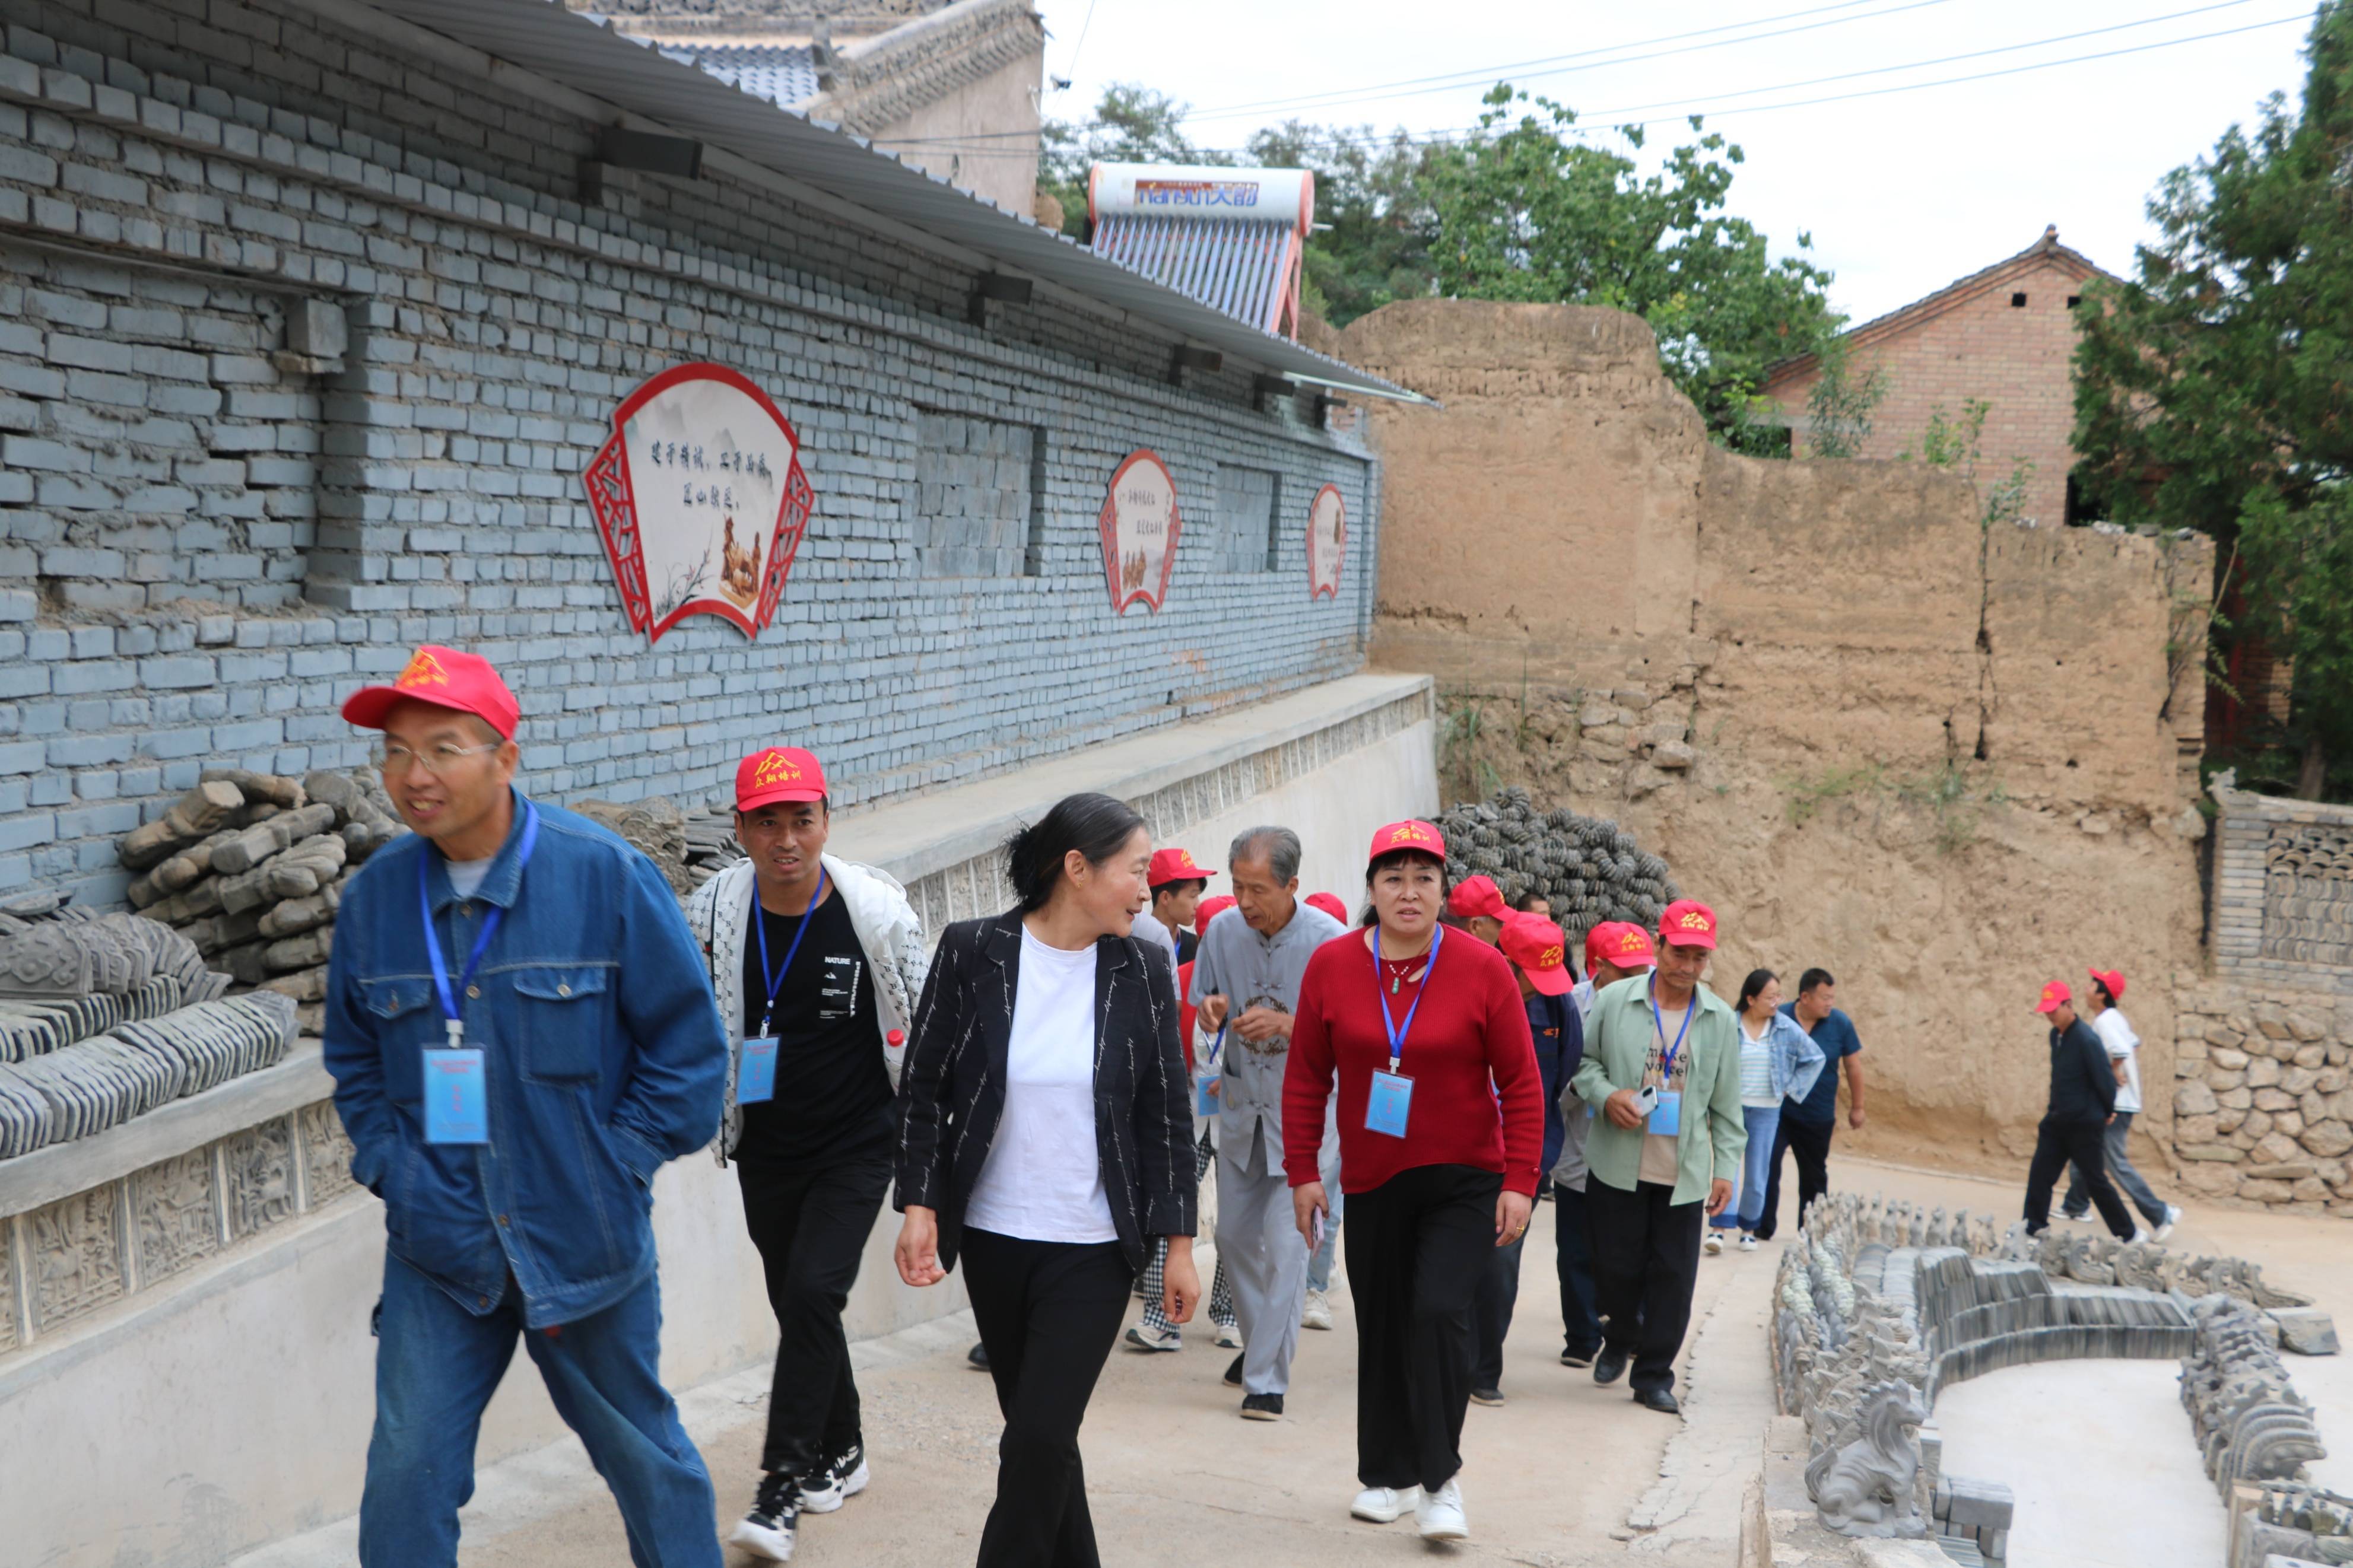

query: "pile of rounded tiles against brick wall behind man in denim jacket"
left=118, top=769, right=407, bottom=1030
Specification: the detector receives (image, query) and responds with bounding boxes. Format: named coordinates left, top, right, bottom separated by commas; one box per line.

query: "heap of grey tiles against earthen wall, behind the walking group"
left=1438, top=785, right=1682, bottom=940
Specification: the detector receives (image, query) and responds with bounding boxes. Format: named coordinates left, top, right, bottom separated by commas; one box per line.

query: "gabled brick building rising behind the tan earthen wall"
left=1765, top=228, right=2109, bottom=524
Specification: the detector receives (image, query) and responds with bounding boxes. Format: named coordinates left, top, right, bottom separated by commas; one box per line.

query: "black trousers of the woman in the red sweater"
left=1341, top=1166, right=1504, bottom=1488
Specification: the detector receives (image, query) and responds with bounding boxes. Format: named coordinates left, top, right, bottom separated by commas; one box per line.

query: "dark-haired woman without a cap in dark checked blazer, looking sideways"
left=894, top=794, right=1200, bottom=1568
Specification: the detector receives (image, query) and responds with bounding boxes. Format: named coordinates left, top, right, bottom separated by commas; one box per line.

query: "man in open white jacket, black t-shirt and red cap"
left=687, top=745, right=929, bottom=1563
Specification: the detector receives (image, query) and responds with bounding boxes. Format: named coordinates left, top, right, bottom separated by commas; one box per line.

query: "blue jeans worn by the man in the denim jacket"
left=360, top=1253, right=720, bottom=1568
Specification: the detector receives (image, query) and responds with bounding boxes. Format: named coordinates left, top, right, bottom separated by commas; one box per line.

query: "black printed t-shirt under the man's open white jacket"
left=736, top=889, right=899, bottom=1166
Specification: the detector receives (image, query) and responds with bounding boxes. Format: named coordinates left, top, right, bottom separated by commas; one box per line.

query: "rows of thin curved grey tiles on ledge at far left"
left=0, top=908, right=294, bottom=1159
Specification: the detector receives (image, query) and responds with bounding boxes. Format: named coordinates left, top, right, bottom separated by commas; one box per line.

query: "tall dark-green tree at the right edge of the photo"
left=2075, top=0, right=2353, bottom=799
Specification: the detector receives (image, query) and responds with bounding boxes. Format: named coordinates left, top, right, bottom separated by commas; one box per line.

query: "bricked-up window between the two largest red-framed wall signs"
left=913, top=409, right=1044, bottom=576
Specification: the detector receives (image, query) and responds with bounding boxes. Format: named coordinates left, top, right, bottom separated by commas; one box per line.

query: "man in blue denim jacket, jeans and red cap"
left=325, top=647, right=727, bottom=1568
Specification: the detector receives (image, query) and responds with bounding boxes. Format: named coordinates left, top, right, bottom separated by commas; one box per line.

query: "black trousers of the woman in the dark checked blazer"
left=965, top=1229, right=1136, bottom=1568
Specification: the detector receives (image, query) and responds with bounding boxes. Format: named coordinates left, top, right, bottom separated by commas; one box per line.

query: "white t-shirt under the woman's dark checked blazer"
left=965, top=926, right=1120, bottom=1241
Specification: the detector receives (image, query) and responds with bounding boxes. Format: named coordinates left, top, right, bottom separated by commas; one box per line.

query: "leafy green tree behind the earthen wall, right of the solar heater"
left=1424, top=85, right=1843, bottom=451
